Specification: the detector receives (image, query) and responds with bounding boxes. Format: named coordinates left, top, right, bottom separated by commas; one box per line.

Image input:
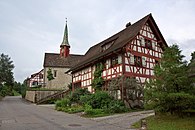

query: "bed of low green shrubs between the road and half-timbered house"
left=55, top=89, right=127, bottom=117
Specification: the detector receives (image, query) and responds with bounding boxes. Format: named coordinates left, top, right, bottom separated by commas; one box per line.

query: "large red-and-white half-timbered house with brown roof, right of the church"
left=69, top=14, right=167, bottom=99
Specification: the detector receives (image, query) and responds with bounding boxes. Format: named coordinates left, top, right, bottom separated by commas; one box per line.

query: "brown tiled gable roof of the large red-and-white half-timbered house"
left=70, top=14, right=167, bottom=72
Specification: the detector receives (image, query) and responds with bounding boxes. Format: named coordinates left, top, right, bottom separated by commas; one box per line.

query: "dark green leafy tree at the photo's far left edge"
left=0, top=53, right=14, bottom=86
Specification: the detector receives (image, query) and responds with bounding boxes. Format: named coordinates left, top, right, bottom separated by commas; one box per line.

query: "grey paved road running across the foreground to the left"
left=0, top=96, right=154, bottom=130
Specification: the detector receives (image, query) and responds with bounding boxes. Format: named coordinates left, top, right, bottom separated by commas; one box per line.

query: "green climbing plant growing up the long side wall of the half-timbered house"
left=92, top=63, right=104, bottom=90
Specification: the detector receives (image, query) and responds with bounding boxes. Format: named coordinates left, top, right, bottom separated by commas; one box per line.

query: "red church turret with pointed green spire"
left=60, top=20, right=70, bottom=58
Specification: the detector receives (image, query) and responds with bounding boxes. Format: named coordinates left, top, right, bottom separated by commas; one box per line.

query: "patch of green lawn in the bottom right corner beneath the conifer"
left=132, top=115, right=195, bottom=130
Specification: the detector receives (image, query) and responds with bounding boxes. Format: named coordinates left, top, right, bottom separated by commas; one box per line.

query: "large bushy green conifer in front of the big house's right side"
left=144, top=45, right=194, bottom=115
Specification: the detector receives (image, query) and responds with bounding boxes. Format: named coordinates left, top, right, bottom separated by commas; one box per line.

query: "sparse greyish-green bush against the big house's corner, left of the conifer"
left=108, top=76, right=143, bottom=109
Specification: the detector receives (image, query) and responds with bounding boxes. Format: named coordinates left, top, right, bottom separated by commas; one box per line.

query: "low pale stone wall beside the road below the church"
left=25, top=90, right=59, bottom=103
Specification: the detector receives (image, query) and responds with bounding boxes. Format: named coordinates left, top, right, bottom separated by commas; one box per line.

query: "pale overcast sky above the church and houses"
left=0, top=0, right=195, bottom=82
